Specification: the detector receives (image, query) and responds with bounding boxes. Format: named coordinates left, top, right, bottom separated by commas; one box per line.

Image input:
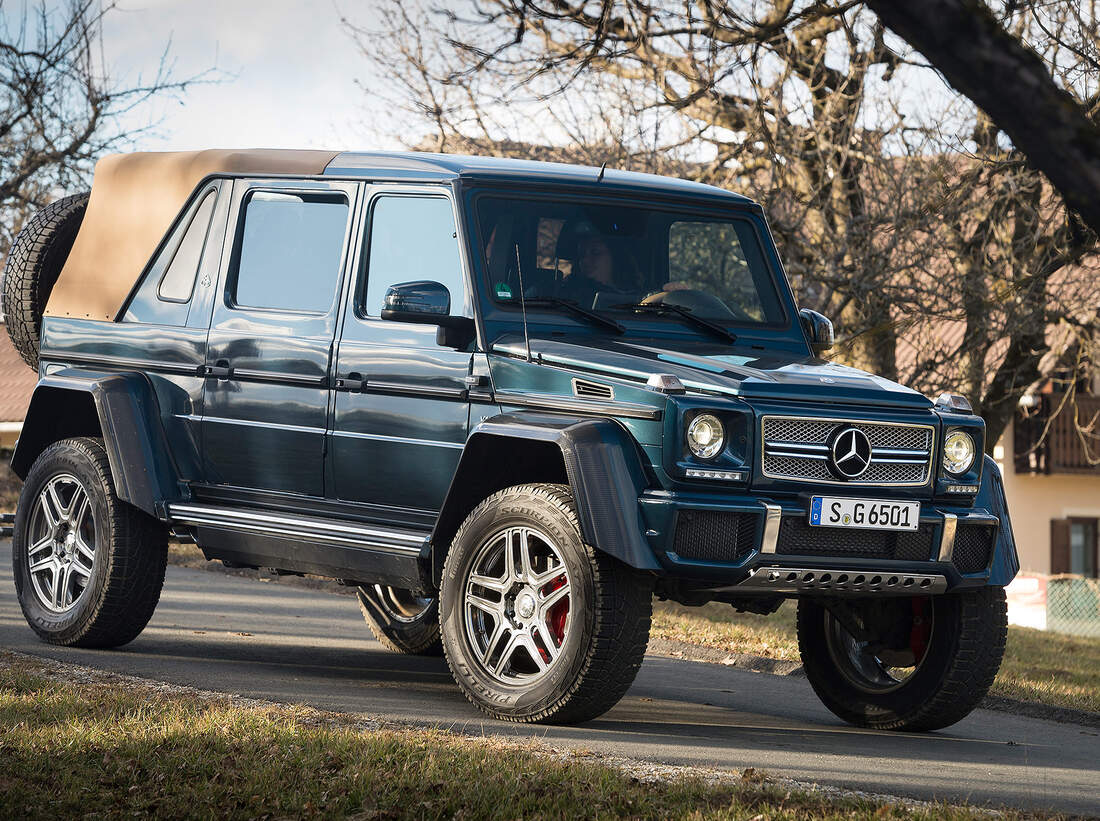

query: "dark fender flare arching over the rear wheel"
left=11, top=368, right=178, bottom=518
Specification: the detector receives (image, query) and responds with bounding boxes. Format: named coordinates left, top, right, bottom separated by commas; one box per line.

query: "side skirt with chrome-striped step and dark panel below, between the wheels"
left=168, top=503, right=431, bottom=591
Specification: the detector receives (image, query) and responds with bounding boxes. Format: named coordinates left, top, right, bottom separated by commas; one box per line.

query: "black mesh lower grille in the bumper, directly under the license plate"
left=776, top=516, right=935, bottom=561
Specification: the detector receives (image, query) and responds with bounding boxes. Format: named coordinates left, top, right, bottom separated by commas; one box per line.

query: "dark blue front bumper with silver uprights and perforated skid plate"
left=639, top=491, right=1000, bottom=595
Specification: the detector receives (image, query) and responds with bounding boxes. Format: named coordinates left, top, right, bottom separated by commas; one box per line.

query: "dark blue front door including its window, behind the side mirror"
left=329, top=188, right=472, bottom=527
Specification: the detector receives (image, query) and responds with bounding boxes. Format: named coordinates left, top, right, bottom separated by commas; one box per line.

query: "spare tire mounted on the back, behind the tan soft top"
left=3, top=191, right=89, bottom=370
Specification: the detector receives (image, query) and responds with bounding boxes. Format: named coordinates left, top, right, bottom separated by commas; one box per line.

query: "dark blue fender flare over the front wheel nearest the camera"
left=431, top=413, right=661, bottom=581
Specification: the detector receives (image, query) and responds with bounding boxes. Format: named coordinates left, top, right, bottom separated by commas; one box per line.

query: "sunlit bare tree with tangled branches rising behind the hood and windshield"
left=349, top=0, right=1100, bottom=447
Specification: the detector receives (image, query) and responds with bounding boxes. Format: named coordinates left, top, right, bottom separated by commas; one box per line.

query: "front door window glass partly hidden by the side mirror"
left=361, top=196, right=465, bottom=317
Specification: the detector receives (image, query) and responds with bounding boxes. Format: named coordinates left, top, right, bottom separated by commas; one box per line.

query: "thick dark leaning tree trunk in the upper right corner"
left=866, top=0, right=1100, bottom=233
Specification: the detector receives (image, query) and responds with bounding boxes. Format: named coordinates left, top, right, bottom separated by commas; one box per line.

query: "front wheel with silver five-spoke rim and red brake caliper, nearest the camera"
left=440, top=484, right=653, bottom=723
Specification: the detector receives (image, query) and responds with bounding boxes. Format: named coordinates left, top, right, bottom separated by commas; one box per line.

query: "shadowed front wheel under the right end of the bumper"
left=799, top=588, right=1008, bottom=732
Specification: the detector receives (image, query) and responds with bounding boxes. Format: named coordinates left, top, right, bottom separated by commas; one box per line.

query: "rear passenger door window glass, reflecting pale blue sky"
left=232, top=191, right=350, bottom=314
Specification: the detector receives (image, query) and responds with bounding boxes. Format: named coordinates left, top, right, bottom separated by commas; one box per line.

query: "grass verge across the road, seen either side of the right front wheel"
left=653, top=602, right=1100, bottom=712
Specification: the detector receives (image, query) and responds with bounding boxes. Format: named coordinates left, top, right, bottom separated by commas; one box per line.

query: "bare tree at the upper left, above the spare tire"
left=0, top=0, right=212, bottom=259
